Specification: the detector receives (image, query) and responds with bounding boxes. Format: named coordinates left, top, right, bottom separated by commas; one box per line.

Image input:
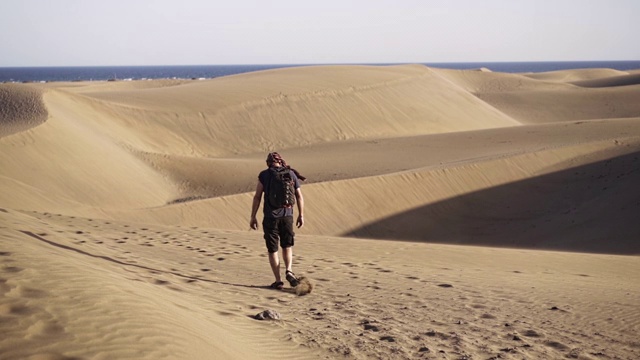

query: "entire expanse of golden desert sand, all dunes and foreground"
left=0, top=65, right=640, bottom=360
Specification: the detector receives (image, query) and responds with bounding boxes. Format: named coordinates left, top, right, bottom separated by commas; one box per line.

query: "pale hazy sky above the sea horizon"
left=0, top=0, right=640, bottom=66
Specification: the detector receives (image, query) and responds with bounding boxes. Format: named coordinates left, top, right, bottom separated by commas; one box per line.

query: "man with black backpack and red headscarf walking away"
left=249, top=152, right=305, bottom=290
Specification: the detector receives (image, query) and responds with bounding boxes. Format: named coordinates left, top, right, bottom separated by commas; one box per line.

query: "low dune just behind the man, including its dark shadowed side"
left=112, top=134, right=640, bottom=254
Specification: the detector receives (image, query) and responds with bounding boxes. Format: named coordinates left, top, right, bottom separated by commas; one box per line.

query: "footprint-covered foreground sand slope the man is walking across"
left=0, top=210, right=640, bottom=359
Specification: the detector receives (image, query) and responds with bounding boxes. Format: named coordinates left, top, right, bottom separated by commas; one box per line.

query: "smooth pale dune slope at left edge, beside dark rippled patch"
left=0, top=89, right=173, bottom=212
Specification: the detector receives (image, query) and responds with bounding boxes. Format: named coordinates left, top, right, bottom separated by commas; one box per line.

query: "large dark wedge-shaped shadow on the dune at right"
left=344, top=152, right=640, bottom=255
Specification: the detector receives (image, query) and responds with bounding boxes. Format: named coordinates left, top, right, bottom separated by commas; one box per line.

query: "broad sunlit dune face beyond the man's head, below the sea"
left=58, top=66, right=517, bottom=157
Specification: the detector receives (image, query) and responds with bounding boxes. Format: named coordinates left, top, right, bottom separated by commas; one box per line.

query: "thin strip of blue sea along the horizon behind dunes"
left=0, top=61, right=640, bottom=82
